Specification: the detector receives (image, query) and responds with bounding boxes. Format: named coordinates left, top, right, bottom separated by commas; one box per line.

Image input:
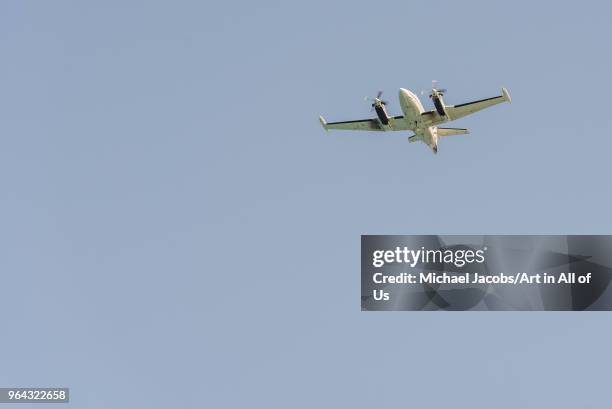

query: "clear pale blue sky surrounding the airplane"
left=0, top=1, right=612, bottom=409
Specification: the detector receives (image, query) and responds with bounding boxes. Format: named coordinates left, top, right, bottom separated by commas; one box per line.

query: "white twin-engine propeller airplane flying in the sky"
left=319, top=80, right=512, bottom=153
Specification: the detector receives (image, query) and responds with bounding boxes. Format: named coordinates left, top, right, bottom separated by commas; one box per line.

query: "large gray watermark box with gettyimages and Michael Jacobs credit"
left=361, top=235, right=612, bottom=311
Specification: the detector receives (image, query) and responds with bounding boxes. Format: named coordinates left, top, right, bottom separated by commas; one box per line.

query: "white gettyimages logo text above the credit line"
left=372, top=246, right=487, bottom=268
